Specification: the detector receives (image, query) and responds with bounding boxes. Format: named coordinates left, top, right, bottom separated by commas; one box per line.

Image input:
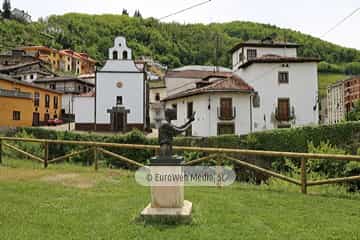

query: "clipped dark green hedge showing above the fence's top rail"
left=7, top=122, right=360, bottom=157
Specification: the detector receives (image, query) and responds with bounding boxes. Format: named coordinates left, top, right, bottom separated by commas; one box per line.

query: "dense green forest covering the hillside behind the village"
left=0, top=13, right=360, bottom=74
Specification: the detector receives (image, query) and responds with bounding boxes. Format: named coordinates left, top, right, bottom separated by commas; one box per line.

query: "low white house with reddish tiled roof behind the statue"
left=164, top=75, right=253, bottom=136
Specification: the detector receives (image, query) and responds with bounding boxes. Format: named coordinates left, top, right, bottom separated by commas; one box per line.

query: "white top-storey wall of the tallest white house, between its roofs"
left=232, top=47, right=297, bottom=71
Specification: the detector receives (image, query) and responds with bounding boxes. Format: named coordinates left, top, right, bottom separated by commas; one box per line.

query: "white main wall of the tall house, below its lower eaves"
left=236, top=63, right=319, bottom=131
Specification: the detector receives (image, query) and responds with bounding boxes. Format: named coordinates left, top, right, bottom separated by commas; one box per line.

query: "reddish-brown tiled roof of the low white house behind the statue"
left=163, top=74, right=254, bottom=101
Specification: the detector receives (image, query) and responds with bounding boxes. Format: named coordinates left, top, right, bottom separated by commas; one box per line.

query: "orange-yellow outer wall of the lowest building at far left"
left=0, top=79, right=62, bottom=126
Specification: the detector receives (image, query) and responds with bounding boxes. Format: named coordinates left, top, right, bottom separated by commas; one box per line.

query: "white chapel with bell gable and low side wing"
left=74, top=37, right=148, bottom=132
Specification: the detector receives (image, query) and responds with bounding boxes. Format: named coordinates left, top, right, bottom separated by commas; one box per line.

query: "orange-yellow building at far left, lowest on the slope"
left=0, top=74, right=62, bottom=127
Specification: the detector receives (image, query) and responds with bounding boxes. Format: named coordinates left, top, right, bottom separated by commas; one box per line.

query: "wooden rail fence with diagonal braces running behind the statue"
left=0, top=137, right=360, bottom=194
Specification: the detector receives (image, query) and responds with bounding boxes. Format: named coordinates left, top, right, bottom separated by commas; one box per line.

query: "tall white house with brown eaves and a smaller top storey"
left=232, top=39, right=319, bottom=131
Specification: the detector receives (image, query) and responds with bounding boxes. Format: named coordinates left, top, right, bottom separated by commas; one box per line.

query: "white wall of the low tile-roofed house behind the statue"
left=166, top=93, right=251, bottom=137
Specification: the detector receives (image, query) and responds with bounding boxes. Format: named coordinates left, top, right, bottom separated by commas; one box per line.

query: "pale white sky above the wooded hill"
left=11, top=0, right=360, bottom=50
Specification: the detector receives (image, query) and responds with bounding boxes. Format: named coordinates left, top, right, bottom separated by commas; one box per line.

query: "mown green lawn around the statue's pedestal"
left=0, top=159, right=360, bottom=240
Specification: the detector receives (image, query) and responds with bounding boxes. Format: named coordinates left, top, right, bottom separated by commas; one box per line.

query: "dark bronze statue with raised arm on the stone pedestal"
left=159, top=109, right=195, bottom=160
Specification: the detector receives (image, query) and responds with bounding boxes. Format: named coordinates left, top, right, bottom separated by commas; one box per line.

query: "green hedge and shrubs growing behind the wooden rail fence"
left=4, top=122, right=360, bottom=191
